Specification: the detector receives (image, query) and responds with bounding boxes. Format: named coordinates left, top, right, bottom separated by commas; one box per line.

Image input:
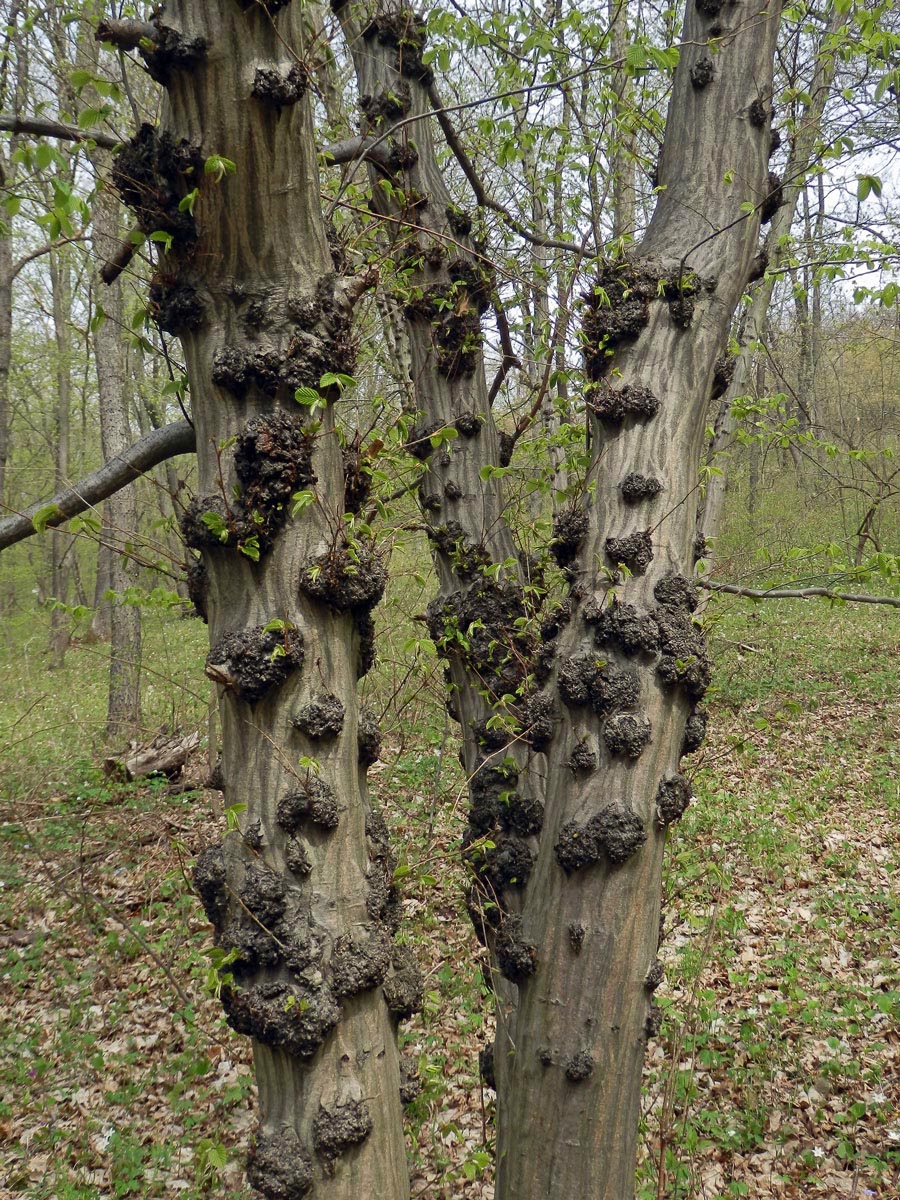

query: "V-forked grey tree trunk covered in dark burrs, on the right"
left=340, top=6, right=778, bottom=1200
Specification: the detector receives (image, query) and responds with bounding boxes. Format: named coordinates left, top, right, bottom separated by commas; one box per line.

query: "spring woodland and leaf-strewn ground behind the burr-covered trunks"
left=0, top=2, right=900, bottom=1198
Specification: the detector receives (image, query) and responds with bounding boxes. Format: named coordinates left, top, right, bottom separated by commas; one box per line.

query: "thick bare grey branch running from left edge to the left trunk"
left=0, top=421, right=197, bottom=550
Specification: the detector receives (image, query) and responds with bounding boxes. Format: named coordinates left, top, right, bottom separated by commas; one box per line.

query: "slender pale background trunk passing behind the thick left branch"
left=94, top=164, right=142, bottom=738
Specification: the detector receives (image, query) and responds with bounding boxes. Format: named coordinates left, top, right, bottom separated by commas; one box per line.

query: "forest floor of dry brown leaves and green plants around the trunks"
left=0, top=601, right=900, bottom=1200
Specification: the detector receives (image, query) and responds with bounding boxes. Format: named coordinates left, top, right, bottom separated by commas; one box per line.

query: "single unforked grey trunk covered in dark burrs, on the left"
left=102, top=0, right=418, bottom=1200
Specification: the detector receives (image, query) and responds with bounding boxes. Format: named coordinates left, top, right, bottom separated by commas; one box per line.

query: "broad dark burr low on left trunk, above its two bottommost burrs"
left=222, top=980, right=341, bottom=1058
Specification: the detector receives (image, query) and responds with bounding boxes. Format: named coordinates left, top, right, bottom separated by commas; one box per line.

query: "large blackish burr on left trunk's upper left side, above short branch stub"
left=112, top=124, right=203, bottom=250
